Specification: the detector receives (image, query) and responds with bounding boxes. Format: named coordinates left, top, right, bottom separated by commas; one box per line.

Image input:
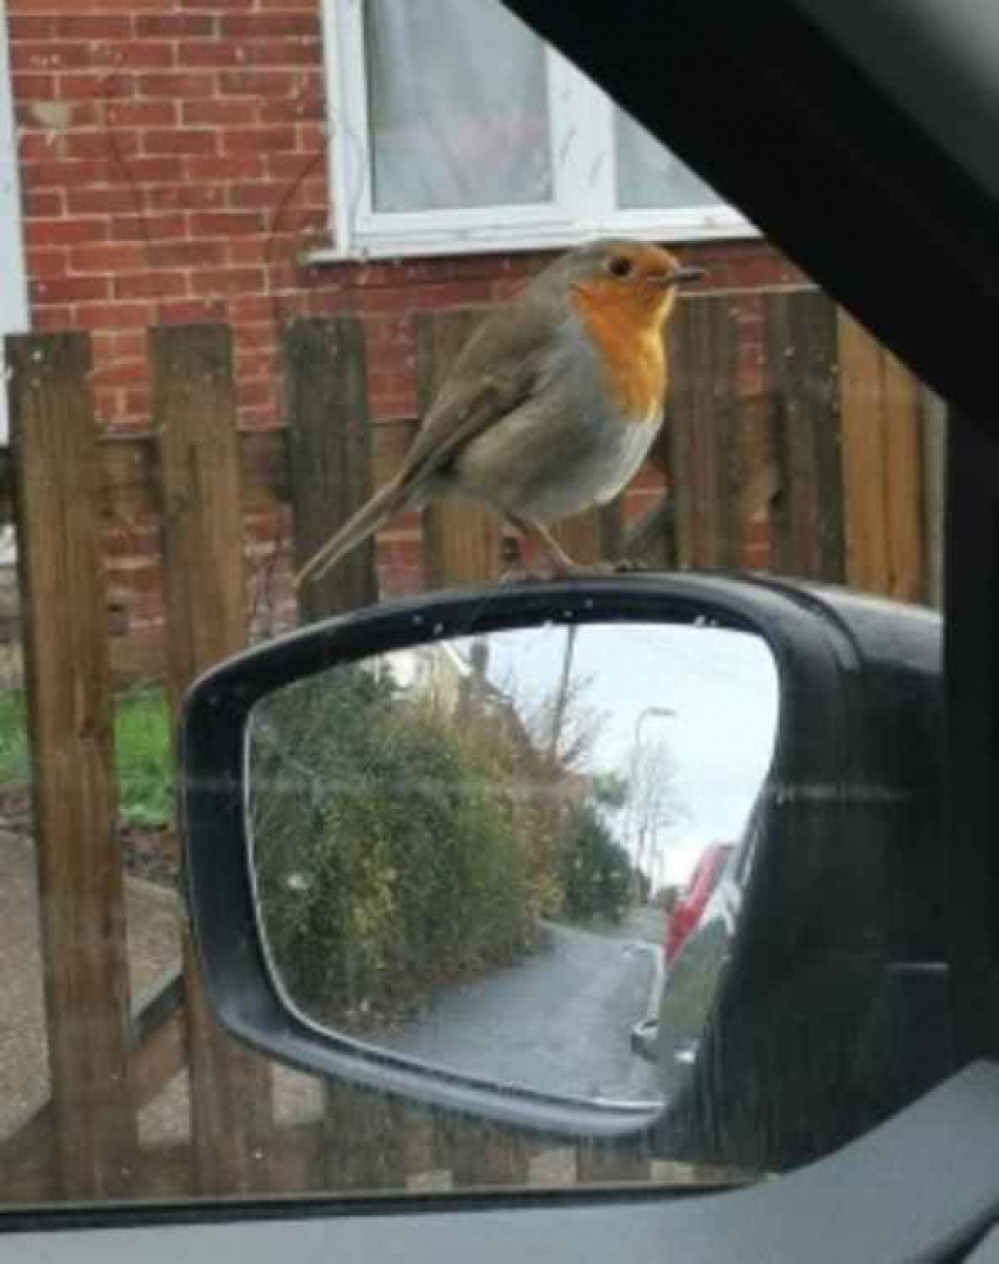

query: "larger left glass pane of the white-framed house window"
left=364, top=0, right=553, bottom=211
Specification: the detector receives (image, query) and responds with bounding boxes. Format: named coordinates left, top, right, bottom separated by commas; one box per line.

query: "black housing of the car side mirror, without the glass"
left=178, top=574, right=951, bottom=1169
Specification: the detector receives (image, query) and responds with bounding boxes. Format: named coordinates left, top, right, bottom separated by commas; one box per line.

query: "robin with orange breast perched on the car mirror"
left=295, top=239, right=703, bottom=585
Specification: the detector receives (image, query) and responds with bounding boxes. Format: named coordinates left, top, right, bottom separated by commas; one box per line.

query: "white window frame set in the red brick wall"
left=312, top=0, right=759, bottom=260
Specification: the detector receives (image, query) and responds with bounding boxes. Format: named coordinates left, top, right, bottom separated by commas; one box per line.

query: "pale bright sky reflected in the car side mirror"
left=392, top=624, right=778, bottom=882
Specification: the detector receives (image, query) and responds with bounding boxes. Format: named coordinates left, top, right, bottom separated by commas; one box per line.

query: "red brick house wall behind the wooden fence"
left=6, top=0, right=793, bottom=672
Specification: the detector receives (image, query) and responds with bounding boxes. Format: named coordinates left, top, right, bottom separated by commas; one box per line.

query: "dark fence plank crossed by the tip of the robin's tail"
left=283, top=316, right=378, bottom=622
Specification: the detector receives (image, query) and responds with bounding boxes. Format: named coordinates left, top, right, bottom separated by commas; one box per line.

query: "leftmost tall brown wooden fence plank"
left=8, top=334, right=137, bottom=1198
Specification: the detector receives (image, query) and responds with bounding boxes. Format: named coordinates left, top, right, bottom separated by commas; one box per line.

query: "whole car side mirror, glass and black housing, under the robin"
left=180, top=575, right=948, bottom=1167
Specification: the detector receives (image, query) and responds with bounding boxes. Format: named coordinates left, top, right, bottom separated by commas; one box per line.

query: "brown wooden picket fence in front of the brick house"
left=0, top=291, right=942, bottom=1201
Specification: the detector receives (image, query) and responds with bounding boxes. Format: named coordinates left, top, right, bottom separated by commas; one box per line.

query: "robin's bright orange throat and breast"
left=569, top=282, right=666, bottom=422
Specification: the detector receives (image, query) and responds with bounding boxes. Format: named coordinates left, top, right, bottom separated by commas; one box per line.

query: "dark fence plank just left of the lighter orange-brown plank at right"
left=763, top=289, right=845, bottom=581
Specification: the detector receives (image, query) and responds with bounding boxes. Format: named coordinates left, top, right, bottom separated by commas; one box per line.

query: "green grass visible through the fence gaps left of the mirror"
left=0, top=689, right=173, bottom=829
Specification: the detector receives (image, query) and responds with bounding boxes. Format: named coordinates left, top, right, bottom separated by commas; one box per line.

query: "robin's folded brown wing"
left=400, top=295, right=565, bottom=485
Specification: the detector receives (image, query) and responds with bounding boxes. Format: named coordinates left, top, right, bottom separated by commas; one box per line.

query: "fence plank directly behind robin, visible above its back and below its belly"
left=416, top=307, right=502, bottom=588
